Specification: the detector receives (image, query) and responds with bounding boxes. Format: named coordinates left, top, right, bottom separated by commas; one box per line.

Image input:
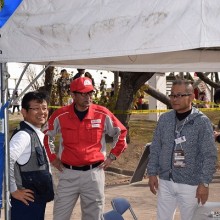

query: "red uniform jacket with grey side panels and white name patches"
left=44, top=103, right=127, bottom=166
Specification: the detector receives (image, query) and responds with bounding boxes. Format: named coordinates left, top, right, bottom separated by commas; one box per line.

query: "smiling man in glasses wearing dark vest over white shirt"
left=9, top=91, right=54, bottom=220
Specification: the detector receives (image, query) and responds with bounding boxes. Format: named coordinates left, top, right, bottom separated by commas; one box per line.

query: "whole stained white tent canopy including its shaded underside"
left=0, top=0, right=220, bottom=71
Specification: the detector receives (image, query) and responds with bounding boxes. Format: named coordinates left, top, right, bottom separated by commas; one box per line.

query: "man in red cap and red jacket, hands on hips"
left=44, top=77, right=127, bottom=220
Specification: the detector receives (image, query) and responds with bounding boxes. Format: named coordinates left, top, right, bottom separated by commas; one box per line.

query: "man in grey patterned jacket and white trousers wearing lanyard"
left=147, top=79, right=217, bottom=220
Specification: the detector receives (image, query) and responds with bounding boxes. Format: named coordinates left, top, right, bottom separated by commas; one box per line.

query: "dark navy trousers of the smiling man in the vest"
left=11, top=197, right=46, bottom=220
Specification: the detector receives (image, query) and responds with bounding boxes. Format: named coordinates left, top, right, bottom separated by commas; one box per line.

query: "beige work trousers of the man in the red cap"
left=53, top=167, right=105, bottom=220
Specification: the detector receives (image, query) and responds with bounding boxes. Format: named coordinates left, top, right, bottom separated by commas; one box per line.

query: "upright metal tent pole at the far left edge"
left=0, top=63, right=11, bottom=220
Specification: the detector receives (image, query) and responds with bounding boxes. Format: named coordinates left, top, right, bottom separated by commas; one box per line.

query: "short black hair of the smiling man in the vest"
left=21, top=91, right=48, bottom=111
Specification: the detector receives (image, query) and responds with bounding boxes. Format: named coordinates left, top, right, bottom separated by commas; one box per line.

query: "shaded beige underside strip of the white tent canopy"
left=34, top=50, right=220, bottom=72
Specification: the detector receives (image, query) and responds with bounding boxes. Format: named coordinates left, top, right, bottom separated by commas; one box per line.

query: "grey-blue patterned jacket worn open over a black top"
left=147, top=107, right=217, bottom=185
